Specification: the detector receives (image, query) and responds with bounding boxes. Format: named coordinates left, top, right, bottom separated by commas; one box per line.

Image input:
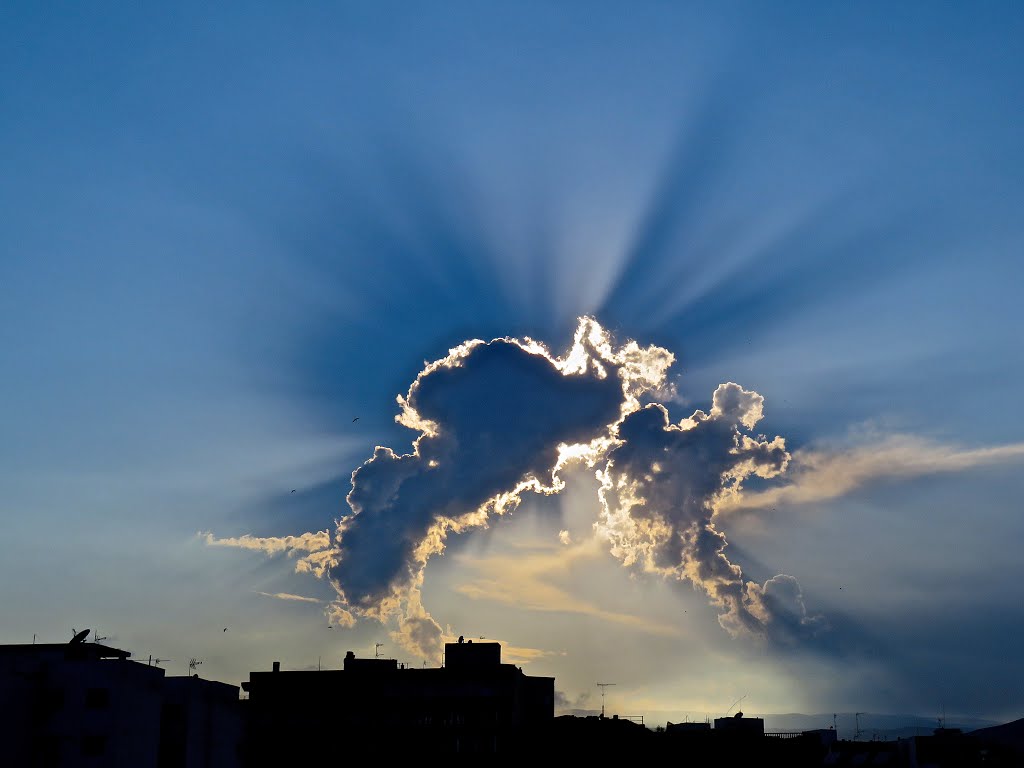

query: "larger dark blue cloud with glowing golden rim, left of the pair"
left=330, top=318, right=674, bottom=657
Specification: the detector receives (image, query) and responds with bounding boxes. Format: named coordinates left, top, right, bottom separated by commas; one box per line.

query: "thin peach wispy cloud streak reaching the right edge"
left=723, top=434, right=1024, bottom=509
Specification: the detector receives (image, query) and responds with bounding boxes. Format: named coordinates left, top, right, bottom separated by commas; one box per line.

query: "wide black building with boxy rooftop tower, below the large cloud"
left=242, top=642, right=555, bottom=765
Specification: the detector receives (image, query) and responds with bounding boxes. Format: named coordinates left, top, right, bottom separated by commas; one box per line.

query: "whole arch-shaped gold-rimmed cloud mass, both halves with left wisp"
left=206, top=317, right=819, bottom=659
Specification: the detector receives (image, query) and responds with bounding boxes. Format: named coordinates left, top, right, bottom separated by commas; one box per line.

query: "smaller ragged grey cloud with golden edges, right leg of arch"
left=596, top=382, right=823, bottom=641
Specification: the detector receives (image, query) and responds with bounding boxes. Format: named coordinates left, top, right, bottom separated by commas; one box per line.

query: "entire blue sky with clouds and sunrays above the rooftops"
left=0, top=0, right=1024, bottom=727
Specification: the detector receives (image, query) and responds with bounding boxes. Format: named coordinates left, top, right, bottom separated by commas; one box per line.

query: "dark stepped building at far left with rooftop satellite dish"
left=0, top=641, right=242, bottom=768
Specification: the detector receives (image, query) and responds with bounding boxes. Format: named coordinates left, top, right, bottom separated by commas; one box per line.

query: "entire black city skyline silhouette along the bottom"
left=0, top=630, right=1024, bottom=768
